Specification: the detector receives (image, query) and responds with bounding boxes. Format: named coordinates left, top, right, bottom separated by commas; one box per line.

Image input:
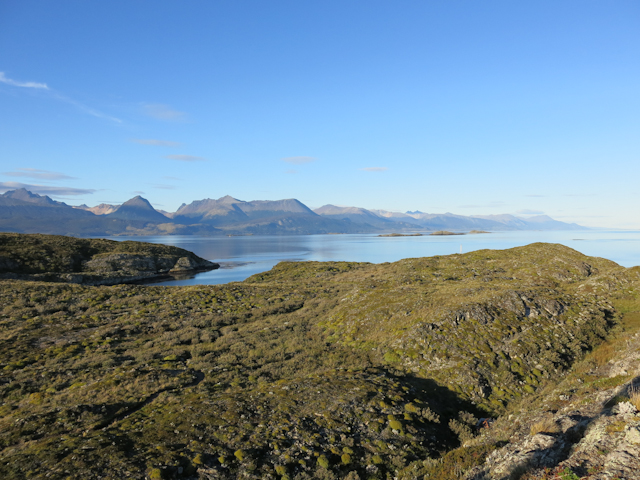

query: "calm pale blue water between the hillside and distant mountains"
left=107, top=230, right=640, bottom=285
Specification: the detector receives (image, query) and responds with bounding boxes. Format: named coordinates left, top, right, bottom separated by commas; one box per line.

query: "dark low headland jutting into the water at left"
left=0, top=233, right=219, bottom=285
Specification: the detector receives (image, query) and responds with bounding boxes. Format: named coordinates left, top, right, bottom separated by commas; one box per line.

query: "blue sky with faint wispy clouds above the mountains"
left=0, top=0, right=640, bottom=229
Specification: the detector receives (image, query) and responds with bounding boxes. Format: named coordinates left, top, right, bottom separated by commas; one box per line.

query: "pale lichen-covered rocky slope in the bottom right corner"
left=463, top=326, right=640, bottom=480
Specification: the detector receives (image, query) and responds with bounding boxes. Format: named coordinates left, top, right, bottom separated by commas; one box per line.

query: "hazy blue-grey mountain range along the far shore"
left=0, top=188, right=585, bottom=236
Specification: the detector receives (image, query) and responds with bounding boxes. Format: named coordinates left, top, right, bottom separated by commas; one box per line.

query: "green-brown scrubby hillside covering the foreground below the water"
left=0, top=234, right=639, bottom=480
